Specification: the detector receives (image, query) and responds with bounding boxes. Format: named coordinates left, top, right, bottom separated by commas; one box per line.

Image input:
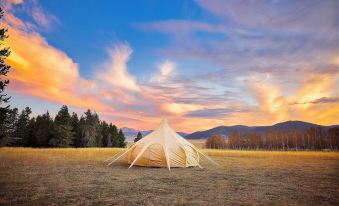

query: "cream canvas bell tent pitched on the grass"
left=107, top=120, right=217, bottom=170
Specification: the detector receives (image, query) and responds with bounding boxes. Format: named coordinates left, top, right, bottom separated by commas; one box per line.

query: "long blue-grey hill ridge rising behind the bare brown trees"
left=186, top=121, right=339, bottom=139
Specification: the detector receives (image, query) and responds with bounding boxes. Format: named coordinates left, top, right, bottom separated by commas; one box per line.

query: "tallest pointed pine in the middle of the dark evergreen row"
left=49, top=105, right=74, bottom=147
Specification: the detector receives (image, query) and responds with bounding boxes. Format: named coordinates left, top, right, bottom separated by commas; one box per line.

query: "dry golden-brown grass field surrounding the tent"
left=0, top=148, right=339, bottom=205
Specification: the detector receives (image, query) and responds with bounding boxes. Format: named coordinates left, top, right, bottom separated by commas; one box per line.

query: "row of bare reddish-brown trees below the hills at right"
left=220, top=127, right=339, bottom=150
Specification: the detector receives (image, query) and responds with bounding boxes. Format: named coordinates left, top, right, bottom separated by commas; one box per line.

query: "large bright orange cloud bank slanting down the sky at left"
left=5, top=17, right=112, bottom=111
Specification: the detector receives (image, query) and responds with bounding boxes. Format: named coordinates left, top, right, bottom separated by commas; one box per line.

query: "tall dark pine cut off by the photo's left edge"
left=0, top=8, right=11, bottom=146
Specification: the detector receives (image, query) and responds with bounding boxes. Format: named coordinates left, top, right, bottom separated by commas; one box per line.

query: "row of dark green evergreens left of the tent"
left=0, top=105, right=126, bottom=147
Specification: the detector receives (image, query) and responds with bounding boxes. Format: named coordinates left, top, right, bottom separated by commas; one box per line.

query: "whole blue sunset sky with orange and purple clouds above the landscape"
left=0, top=0, right=339, bottom=132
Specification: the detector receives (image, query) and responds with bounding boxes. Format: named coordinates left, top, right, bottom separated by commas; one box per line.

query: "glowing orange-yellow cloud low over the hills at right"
left=244, top=69, right=339, bottom=125
